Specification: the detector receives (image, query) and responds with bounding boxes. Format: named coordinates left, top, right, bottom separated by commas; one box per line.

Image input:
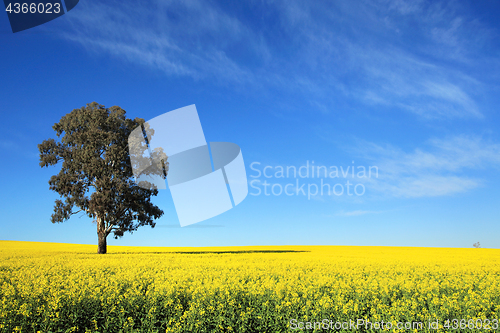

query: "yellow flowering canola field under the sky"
left=0, top=241, right=500, bottom=333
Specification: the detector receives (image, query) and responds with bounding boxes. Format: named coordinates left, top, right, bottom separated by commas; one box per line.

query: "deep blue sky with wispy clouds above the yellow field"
left=0, top=0, right=500, bottom=248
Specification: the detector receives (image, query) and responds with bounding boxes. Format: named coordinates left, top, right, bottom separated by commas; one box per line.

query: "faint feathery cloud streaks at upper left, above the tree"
left=59, top=0, right=258, bottom=83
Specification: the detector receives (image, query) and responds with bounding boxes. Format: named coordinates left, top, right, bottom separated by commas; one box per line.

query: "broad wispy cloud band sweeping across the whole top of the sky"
left=60, top=0, right=489, bottom=119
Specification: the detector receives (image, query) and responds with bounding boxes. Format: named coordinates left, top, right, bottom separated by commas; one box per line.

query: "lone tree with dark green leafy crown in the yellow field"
left=38, top=102, right=168, bottom=254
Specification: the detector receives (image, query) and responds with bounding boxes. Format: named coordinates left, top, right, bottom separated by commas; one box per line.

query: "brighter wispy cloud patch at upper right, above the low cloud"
left=358, top=49, right=482, bottom=118
